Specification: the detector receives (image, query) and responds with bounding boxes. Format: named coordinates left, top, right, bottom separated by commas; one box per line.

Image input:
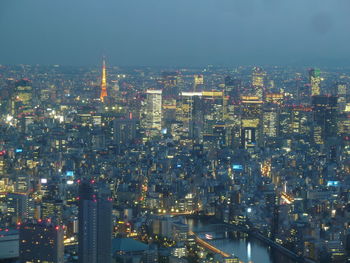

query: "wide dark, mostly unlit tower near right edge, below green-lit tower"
left=312, top=95, right=337, bottom=144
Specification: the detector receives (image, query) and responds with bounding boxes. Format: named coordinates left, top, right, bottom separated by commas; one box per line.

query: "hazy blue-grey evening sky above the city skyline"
left=0, top=0, right=350, bottom=66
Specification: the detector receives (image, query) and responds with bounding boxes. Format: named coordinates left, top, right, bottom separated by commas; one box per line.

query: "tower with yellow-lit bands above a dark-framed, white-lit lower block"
left=241, top=96, right=263, bottom=148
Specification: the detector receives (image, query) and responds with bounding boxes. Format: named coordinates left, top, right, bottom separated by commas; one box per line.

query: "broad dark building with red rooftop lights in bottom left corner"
left=19, top=221, right=64, bottom=263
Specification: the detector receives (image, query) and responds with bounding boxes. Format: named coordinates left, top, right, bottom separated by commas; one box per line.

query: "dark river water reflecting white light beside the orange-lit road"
left=186, top=218, right=296, bottom=263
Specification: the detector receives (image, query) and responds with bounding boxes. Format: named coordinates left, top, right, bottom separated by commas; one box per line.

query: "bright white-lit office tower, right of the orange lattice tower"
left=144, top=90, right=162, bottom=135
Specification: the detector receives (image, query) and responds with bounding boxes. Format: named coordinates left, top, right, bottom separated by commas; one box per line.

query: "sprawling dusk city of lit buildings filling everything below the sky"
left=0, top=61, right=350, bottom=263
